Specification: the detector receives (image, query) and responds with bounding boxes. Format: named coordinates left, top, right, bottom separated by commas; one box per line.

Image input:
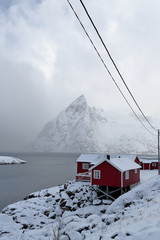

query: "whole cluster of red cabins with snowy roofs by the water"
left=76, top=154, right=158, bottom=198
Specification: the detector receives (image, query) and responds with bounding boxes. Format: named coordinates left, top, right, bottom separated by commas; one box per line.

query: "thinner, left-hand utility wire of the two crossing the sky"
left=67, top=0, right=155, bottom=136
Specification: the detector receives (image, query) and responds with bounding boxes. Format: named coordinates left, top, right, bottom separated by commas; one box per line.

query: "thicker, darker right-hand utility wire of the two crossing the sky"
left=80, top=0, right=157, bottom=132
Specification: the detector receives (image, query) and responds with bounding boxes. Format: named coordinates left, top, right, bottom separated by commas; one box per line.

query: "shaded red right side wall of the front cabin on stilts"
left=123, top=169, right=140, bottom=187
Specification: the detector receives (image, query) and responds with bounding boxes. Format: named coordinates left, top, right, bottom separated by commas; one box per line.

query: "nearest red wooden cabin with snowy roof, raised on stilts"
left=90, top=158, right=141, bottom=188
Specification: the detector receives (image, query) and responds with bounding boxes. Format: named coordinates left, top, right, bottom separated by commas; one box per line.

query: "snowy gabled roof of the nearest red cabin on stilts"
left=89, top=158, right=141, bottom=172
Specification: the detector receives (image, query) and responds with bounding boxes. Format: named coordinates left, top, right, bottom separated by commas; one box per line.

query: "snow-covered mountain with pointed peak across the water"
left=29, top=95, right=160, bottom=154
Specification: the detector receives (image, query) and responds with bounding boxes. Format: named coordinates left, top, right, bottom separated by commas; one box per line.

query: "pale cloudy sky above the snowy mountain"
left=0, top=0, right=160, bottom=151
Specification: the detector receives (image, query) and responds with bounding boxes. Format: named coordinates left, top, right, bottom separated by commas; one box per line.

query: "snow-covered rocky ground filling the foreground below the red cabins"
left=0, top=170, right=160, bottom=240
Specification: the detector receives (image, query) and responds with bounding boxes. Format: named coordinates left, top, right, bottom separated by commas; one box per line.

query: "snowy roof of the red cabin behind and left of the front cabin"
left=76, top=153, right=107, bottom=164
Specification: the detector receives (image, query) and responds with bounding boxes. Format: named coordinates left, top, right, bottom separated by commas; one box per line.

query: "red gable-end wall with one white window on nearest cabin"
left=91, top=161, right=121, bottom=187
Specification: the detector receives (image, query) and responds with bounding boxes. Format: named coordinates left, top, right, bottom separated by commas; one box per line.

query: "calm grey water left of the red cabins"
left=0, top=153, right=79, bottom=211
